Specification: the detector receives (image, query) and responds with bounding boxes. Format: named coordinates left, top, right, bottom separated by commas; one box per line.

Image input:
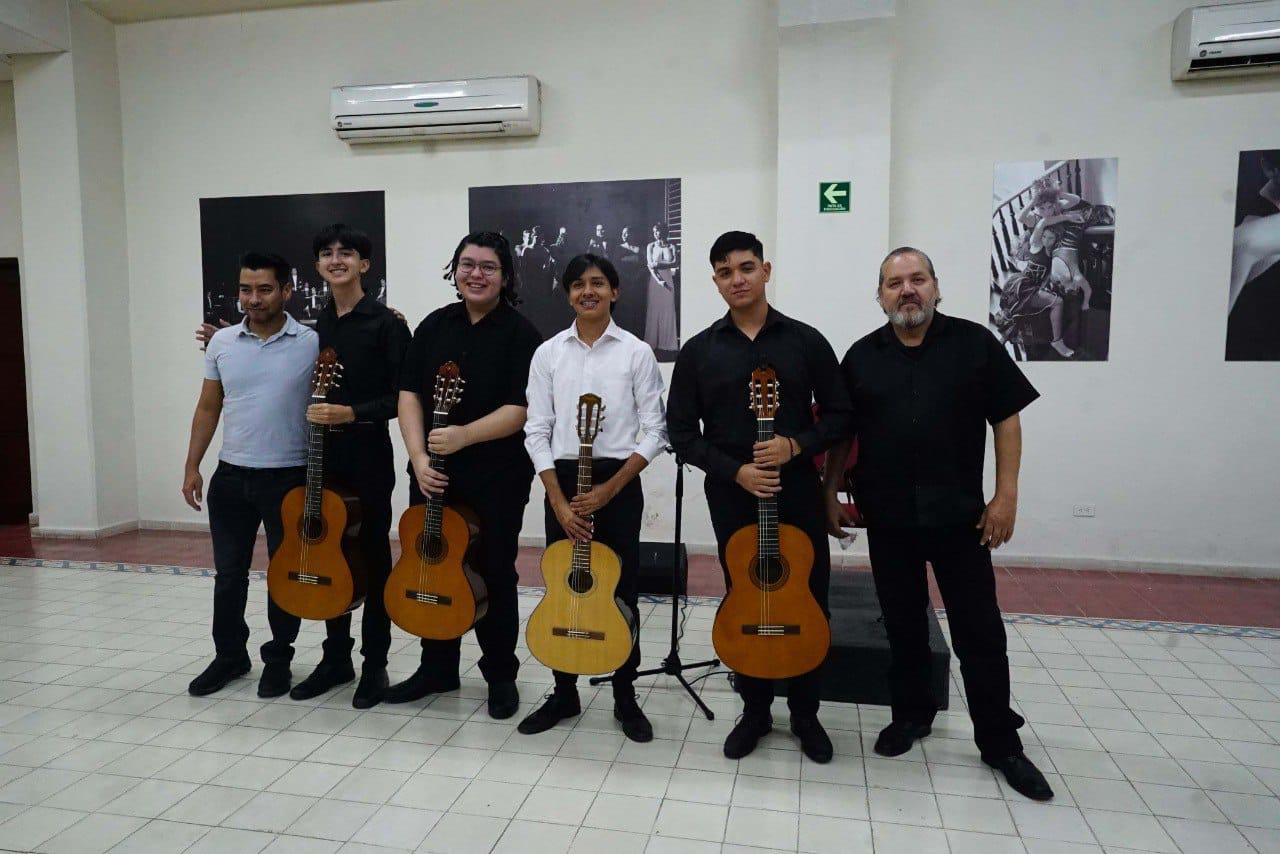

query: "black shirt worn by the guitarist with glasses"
left=401, top=302, right=543, bottom=474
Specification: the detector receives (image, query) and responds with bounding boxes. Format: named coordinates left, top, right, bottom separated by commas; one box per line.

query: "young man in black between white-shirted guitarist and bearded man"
left=667, top=232, right=850, bottom=762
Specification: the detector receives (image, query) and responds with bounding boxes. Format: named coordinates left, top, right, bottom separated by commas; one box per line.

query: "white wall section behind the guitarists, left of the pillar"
left=118, top=0, right=777, bottom=542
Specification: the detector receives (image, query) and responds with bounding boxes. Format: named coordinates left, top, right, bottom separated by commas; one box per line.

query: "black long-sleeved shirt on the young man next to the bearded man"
left=667, top=307, right=850, bottom=481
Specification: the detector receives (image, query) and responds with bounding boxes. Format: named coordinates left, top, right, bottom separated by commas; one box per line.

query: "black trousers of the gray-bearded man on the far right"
left=867, top=528, right=1025, bottom=758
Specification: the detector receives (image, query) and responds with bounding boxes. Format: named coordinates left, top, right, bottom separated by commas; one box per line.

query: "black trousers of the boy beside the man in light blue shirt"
left=264, top=424, right=396, bottom=671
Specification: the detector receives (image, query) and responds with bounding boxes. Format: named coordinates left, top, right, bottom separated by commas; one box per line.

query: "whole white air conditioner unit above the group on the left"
left=330, top=77, right=541, bottom=143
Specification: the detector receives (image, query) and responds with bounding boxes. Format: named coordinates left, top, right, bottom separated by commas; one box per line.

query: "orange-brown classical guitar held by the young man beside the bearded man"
left=712, top=367, right=831, bottom=679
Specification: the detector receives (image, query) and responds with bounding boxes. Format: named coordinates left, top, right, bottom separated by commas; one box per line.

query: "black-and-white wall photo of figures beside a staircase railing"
left=988, top=157, right=1119, bottom=361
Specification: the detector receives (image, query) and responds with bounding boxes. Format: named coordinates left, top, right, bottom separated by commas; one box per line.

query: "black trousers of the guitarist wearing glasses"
left=408, top=466, right=532, bottom=684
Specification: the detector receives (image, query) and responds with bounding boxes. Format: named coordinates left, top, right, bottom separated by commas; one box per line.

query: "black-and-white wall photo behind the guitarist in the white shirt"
left=470, top=178, right=684, bottom=361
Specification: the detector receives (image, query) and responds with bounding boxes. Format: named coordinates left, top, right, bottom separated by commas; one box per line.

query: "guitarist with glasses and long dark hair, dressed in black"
left=387, top=232, right=543, bottom=720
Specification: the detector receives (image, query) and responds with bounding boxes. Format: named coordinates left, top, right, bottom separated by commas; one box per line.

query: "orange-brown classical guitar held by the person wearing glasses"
left=384, top=362, right=489, bottom=640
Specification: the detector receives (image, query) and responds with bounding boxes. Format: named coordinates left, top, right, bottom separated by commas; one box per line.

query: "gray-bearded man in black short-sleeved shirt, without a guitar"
left=826, top=246, right=1053, bottom=800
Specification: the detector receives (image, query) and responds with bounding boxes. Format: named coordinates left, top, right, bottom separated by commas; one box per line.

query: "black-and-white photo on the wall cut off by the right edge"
left=1226, top=149, right=1280, bottom=362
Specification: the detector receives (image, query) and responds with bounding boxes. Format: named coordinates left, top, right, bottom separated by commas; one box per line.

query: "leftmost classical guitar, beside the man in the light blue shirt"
left=266, top=347, right=367, bottom=620
